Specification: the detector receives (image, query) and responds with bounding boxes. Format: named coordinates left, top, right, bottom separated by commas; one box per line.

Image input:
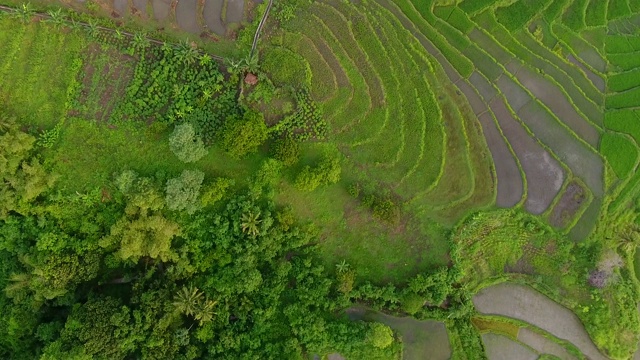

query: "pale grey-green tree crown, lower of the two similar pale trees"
left=165, top=170, right=204, bottom=214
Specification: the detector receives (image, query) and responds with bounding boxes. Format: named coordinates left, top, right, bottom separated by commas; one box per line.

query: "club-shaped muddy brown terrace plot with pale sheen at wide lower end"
left=490, top=97, right=564, bottom=215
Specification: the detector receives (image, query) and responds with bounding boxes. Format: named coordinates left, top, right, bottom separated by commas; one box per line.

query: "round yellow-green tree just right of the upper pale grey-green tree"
left=219, top=110, right=267, bottom=158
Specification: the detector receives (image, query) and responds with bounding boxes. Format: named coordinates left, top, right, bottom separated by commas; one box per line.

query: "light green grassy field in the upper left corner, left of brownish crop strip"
left=0, top=17, right=86, bottom=130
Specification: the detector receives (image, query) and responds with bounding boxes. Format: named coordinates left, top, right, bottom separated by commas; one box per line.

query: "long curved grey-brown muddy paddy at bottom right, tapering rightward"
left=473, top=283, right=607, bottom=360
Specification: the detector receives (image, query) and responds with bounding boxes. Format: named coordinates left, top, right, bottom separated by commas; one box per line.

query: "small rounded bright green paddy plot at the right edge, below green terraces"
left=599, top=132, right=638, bottom=179
